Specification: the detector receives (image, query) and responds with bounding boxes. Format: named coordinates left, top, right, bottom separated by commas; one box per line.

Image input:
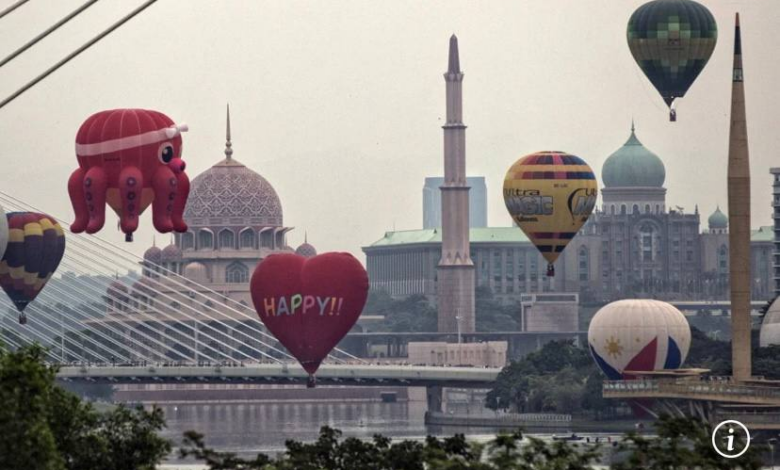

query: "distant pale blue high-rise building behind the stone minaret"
left=423, top=176, right=487, bottom=229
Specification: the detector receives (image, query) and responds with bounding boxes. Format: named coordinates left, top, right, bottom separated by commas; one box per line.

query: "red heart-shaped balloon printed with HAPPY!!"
left=250, top=253, right=368, bottom=374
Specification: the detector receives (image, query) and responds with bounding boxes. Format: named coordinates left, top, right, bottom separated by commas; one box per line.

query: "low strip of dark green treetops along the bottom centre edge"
left=180, top=427, right=599, bottom=470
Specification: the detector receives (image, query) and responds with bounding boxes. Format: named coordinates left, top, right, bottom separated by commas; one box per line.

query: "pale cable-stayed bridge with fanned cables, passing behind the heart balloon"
left=0, top=192, right=499, bottom=411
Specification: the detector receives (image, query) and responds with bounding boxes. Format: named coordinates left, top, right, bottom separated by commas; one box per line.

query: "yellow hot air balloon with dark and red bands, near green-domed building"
left=504, top=152, right=598, bottom=276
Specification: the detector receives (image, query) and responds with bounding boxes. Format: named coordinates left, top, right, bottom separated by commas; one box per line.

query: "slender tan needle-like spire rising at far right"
left=728, top=13, right=752, bottom=381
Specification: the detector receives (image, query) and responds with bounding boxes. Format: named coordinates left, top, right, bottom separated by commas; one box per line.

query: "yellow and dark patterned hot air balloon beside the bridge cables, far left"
left=0, top=212, right=65, bottom=324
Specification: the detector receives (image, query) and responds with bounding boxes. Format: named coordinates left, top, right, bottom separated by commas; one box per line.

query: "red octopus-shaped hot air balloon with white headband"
left=68, top=109, right=190, bottom=241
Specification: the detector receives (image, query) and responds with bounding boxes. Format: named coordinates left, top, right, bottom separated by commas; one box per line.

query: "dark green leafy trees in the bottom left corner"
left=0, top=346, right=170, bottom=470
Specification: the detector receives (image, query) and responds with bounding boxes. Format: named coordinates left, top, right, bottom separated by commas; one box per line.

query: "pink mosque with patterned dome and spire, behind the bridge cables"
left=101, top=110, right=317, bottom=357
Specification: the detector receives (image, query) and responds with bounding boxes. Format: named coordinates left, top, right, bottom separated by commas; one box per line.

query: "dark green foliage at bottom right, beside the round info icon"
left=612, top=416, right=765, bottom=470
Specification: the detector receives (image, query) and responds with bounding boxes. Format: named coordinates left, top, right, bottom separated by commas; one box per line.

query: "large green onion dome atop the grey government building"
left=601, top=124, right=666, bottom=188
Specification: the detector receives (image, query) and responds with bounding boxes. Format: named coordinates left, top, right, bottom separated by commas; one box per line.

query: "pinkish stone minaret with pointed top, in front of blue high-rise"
left=437, top=34, right=475, bottom=333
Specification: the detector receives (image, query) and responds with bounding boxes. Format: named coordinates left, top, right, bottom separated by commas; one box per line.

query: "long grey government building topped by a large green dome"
left=363, top=126, right=774, bottom=303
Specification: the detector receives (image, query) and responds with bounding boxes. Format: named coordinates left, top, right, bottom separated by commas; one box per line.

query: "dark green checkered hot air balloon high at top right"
left=627, top=0, right=718, bottom=121
